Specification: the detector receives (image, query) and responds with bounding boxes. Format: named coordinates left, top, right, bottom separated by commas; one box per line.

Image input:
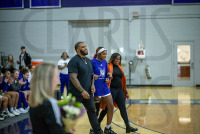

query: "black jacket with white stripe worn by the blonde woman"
left=29, top=99, right=68, bottom=134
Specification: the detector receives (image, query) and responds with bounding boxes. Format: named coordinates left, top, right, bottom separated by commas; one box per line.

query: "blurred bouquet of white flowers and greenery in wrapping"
left=58, top=93, right=85, bottom=133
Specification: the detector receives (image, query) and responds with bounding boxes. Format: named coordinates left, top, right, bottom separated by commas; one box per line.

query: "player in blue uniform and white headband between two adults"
left=91, top=48, right=116, bottom=134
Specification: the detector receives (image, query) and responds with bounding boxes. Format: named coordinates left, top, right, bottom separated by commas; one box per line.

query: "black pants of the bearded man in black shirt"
left=76, top=95, right=103, bottom=134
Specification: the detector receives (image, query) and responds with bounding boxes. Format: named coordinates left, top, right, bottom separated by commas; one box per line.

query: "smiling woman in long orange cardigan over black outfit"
left=98, top=53, right=138, bottom=133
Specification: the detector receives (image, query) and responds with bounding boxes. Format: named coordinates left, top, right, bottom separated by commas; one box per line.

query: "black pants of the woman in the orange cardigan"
left=98, top=88, right=130, bottom=127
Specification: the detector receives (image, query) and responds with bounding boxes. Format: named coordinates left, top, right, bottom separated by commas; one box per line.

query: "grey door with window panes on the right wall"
left=173, top=41, right=194, bottom=86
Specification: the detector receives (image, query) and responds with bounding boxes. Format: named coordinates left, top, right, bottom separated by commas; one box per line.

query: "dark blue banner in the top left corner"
left=0, top=0, right=24, bottom=9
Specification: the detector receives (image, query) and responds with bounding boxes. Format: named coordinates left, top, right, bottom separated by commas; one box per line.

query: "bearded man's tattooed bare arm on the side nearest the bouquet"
left=69, top=73, right=90, bottom=99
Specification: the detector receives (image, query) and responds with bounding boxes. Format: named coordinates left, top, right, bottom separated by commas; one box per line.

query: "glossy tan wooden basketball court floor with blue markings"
left=0, top=87, right=200, bottom=134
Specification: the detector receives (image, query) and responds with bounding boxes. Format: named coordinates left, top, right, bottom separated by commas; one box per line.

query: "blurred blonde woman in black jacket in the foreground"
left=29, top=63, right=70, bottom=134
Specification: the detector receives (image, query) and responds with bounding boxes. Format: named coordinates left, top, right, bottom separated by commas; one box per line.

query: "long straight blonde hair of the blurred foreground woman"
left=30, top=63, right=55, bottom=107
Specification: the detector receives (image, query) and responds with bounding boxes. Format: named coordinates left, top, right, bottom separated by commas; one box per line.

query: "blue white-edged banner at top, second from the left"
left=30, top=0, right=61, bottom=8
